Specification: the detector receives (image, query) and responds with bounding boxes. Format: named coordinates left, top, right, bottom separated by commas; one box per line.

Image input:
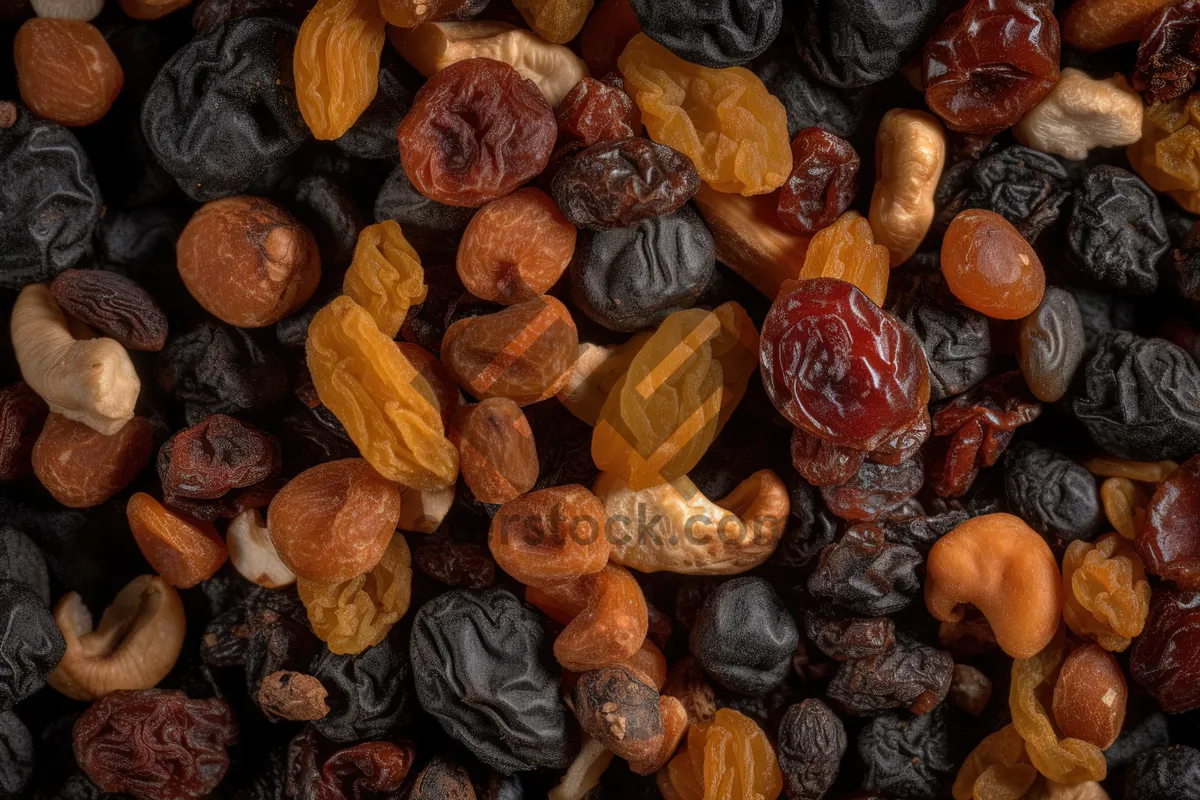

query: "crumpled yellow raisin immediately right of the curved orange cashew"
left=1062, top=534, right=1150, bottom=652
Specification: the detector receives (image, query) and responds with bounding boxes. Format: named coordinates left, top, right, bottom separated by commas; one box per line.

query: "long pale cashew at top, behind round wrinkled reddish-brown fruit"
left=388, top=22, right=588, bottom=108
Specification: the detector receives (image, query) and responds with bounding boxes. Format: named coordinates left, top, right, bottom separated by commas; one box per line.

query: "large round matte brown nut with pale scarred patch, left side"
left=175, top=196, right=320, bottom=327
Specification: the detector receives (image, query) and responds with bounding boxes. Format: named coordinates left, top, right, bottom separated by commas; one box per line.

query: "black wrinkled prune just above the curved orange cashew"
left=1004, top=441, right=1105, bottom=551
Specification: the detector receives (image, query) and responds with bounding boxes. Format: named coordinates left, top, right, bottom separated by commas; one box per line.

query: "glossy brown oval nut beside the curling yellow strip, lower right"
left=1051, top=644, right=1129, bottom=750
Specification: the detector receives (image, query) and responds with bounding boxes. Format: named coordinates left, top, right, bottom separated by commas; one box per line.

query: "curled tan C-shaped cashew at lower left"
left=49, top=575, right=186, bottom=700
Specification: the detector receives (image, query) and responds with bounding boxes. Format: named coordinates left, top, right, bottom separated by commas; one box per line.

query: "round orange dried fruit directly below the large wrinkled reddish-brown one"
left=457, top=187, right=575, bottom=306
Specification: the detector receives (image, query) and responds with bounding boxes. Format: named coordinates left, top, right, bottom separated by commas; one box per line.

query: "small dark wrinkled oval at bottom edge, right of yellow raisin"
left=778, top=698, right=847, bottom=800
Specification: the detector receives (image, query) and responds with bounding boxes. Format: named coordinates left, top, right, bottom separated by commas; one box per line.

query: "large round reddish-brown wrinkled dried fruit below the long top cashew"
left=397, top=59, right=558, bottom=207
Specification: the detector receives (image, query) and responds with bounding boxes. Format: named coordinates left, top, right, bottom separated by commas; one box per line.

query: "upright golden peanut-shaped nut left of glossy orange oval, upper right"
left=870, top=108, right=946, bottom=266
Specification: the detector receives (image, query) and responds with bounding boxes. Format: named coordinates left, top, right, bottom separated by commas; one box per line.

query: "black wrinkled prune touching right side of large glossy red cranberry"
left=900, top=291, right=991, bottom=401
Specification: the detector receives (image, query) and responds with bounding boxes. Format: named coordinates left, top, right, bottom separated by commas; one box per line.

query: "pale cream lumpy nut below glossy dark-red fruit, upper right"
left=1013, top=67, right=1142, bottom=161
